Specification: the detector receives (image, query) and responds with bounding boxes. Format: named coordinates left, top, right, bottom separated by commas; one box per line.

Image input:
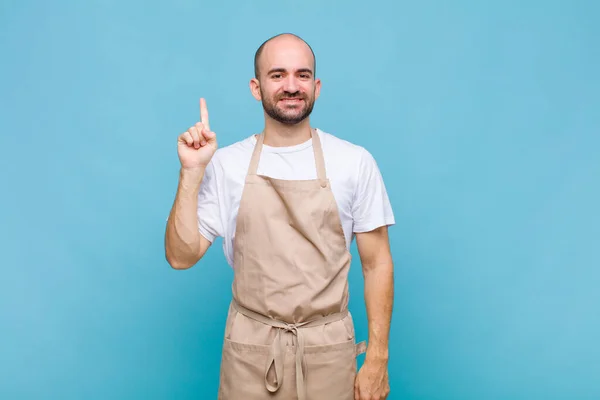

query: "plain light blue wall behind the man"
left=0, top=0, right=600, bottom=400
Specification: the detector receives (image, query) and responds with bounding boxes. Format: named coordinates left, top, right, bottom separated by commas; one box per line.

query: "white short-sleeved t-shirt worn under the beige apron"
left=198, top=129, right=395, bottom=266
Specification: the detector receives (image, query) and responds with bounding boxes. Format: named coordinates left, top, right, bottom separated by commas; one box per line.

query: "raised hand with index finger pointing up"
left=177, top=99, right=217, bottom=169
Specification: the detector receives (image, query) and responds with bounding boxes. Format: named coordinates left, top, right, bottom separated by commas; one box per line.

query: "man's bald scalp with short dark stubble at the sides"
left=254, top=33, right=317, bottom=79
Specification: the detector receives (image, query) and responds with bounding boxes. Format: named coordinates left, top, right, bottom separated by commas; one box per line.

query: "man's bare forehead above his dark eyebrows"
left=260, top=37, right=314, bottom=71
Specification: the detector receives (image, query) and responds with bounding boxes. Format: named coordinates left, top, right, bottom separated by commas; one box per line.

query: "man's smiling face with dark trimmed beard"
left=253, top=38, right=320, bottom=125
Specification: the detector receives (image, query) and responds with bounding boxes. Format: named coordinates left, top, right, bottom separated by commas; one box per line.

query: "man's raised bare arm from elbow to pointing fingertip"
left=165, top=99, right=217, bottom=269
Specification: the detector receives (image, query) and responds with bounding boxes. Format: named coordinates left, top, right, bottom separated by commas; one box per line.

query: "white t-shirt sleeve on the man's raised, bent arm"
left=197, top=161, right=223, bottom=243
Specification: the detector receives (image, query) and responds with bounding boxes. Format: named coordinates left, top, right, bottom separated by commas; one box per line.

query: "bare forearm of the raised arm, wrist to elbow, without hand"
left=165, top=168, right=204, bottom=269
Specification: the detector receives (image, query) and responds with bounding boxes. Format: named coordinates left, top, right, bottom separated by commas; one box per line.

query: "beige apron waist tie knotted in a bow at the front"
left=232, top=299, right=348, bottom=400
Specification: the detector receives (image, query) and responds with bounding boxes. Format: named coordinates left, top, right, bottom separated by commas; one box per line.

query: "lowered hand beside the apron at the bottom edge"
left=354, top=359, right=390, bottom=400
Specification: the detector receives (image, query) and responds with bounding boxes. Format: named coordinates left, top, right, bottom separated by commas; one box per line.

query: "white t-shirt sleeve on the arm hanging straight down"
left=352, top=149, right=395, bottom=232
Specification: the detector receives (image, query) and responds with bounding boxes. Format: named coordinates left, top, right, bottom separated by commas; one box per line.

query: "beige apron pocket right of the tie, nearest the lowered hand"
left=304, top=340, right=357, bottom=400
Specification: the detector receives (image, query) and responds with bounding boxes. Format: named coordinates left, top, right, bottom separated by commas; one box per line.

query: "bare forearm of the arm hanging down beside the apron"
left=363, top=257, right=394, bottom=361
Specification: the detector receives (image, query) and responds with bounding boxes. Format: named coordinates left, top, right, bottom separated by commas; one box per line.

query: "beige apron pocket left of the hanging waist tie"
left=219, top=338, right=270, bottom=400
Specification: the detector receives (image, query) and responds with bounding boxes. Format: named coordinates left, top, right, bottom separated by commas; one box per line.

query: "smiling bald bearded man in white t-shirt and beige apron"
left=165, top=34, right=394, bottom=400
